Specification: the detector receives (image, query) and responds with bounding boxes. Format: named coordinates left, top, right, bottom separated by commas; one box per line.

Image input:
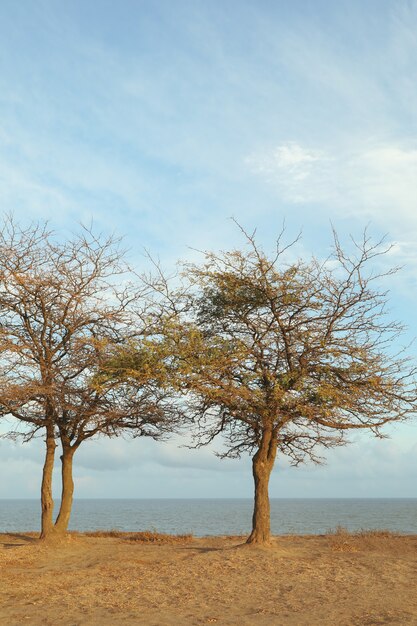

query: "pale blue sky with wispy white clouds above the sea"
left=0, top=0, right=417, bottom=498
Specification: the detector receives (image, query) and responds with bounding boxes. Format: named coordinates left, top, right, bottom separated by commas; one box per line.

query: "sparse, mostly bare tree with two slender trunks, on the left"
left=0, top=217, right=175, bottom=538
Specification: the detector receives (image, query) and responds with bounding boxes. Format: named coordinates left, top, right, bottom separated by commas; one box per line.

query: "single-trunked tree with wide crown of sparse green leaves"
left=161, top=223, right=417, bottom=544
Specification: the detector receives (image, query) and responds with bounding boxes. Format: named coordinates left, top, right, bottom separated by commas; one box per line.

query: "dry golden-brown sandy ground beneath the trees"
left=0, top=531, right=417, bottom=626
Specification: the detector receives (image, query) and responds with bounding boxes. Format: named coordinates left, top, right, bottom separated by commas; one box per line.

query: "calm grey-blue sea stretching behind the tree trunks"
left=0, top=498, right=417, bottom=537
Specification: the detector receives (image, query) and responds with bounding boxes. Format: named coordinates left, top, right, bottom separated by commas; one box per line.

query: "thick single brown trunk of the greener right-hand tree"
left=246, top=431, right=277, bottom=545
